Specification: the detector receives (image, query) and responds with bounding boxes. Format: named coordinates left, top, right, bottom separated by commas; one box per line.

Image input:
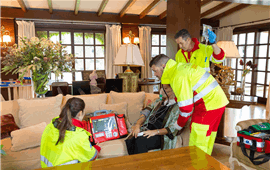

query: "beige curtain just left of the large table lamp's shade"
left=106, top=25, right=123, bottom=79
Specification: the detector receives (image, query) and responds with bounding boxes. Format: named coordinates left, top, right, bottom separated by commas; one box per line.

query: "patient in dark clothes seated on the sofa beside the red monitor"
left=126, top=86, right=179, bottom=155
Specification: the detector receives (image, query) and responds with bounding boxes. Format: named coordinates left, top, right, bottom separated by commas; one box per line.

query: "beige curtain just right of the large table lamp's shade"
left=139, top=26, right=153, bottom=93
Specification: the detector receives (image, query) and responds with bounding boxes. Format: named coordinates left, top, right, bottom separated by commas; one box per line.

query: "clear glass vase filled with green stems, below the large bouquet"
left=32, top=68, right=50, bottom=98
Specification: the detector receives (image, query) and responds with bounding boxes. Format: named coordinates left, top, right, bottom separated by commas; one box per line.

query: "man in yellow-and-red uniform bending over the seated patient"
left=150, top=54, right=229, bottom=155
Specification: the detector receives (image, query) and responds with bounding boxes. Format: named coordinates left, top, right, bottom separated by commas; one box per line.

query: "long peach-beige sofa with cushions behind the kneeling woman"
left=0, top=92, right=189, bottom=170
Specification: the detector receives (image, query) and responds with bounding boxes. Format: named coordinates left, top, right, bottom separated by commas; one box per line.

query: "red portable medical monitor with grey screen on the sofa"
left=81, top=110, right=128, bottom=143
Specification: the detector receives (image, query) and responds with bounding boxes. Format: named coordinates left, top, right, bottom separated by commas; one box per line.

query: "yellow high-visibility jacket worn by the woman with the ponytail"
left=40, top=118, right=98, bottom=168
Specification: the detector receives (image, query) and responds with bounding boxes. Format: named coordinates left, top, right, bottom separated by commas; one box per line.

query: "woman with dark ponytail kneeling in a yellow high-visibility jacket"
left=40, top=97, right=100, bottom=168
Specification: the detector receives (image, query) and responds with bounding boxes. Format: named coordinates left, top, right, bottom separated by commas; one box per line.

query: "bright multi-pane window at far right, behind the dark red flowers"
left=231, top=31, right=270, bottom=98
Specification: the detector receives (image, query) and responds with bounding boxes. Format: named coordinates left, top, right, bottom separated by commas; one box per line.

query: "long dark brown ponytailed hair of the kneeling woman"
left=55, top=97, right=85, bottom=145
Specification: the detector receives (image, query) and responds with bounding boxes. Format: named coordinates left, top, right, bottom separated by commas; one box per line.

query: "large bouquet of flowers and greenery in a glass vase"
left=2, top=37, right=74, bottom=96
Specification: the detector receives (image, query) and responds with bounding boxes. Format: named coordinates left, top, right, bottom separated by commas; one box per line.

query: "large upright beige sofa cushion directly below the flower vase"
left=18, top=94, right=63, bottom=128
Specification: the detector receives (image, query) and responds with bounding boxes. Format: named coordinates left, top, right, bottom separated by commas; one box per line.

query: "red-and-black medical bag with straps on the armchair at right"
left=237, top=122, right=270, bottom=165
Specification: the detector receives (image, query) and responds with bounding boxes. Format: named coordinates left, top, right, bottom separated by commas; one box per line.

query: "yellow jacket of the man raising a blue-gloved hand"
left=175, top=43, right=225, bottom=72
